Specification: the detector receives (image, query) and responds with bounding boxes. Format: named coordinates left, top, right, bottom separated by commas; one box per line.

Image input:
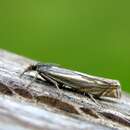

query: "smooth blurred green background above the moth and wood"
left=0, top=0, right=130, bottom=92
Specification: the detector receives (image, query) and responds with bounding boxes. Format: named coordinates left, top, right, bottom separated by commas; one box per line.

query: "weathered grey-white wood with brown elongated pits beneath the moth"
left=0, top=50, right=130, bottom=130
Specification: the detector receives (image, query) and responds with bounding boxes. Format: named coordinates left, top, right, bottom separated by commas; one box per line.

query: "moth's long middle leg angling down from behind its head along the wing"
left=39, top=73, right=62, bottom=95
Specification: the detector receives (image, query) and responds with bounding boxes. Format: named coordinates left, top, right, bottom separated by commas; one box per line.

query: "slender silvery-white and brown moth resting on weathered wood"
left=21, top=63, right=121, bottom=98
